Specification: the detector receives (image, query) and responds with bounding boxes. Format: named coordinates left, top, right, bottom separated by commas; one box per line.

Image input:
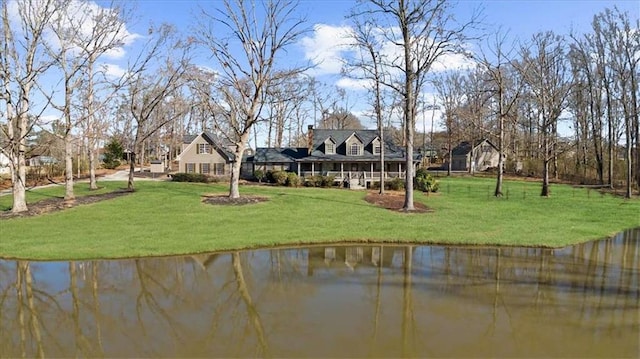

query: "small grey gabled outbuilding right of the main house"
left=444, top=139, right=500, bottom=172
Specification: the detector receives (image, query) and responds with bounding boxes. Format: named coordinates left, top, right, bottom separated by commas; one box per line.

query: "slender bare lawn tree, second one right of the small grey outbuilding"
left=518, top=32, right=571, bottom=197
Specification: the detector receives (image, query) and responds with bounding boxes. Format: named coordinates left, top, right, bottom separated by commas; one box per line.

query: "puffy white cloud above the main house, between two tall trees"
left=301, top=24, right=351, bottom=75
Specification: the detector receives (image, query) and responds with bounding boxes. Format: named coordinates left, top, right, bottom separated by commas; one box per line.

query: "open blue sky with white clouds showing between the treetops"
left=22, top=0, right=640, bottom=139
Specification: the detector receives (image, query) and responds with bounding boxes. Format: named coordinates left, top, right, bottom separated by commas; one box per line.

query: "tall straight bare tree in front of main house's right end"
left=356, top=0, right=477, bottom=211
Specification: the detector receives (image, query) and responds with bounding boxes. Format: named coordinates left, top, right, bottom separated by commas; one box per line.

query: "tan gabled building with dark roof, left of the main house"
left=176, top=132, right=235, bottom=176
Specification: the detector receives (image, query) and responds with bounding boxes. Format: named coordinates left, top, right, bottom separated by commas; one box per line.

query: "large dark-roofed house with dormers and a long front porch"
left=247, top=126, right=420, bottom=187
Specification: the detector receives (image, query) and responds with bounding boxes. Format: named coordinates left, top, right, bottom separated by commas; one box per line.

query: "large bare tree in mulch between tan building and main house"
left=197, top=0, right=306, bottom=198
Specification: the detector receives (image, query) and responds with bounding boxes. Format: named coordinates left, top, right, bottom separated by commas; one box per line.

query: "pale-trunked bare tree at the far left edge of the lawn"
left=0, top=0, right=58, bottom=213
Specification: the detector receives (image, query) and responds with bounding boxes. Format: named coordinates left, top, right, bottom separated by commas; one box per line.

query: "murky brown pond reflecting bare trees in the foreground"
left=0, top=229, right=640, bottom=357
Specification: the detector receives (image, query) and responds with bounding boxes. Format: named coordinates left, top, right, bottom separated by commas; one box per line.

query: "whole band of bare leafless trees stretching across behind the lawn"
left=0, top=0, right=640, bottom=217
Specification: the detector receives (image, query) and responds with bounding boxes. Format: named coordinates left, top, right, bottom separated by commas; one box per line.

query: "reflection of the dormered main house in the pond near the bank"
left=307, top=245, right=404, bottom=276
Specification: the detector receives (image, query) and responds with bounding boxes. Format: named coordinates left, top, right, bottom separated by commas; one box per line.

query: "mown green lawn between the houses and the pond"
left=0, top=178, right=640, bottom=260
